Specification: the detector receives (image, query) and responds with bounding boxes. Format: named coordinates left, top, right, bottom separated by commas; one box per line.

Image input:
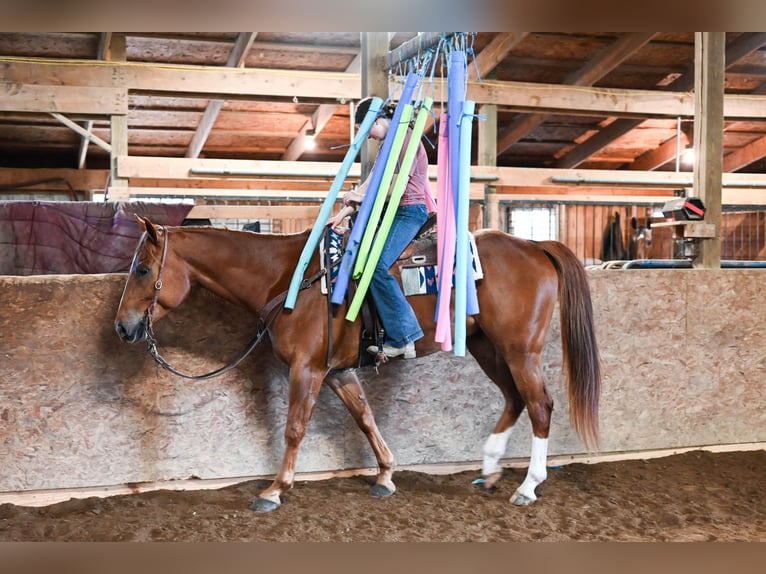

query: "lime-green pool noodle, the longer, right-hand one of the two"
left=346, top=98, right=433, bottom=321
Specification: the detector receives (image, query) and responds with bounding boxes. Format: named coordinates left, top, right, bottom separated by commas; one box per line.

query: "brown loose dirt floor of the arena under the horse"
left=0, top=450, right=766, bottom=542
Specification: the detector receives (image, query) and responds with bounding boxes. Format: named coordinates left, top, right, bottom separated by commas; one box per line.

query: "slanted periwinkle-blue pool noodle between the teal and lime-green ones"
left=330, top=72, right=418, bottom=305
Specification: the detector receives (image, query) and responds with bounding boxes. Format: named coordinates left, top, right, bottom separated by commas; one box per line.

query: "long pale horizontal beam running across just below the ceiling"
left=0, top=57, right=766, bottom=120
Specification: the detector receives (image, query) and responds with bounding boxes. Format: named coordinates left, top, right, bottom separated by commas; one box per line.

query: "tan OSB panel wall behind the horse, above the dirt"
left=0, top=270, right=766, bottom=492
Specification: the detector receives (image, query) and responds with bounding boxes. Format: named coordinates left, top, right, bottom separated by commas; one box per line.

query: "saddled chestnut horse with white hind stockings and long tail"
left=114, top=218, right=601, bottom=512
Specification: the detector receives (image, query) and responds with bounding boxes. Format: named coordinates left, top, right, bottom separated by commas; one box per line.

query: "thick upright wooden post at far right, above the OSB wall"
left=692, top=32, right=726, bottom=269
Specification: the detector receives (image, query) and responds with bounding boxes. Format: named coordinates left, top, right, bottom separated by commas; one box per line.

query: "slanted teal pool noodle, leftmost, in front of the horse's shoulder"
left=285, top=97, right=383, bottom=309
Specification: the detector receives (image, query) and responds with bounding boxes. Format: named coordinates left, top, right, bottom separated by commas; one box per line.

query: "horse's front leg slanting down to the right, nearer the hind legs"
left=326, top=371, right=396, bottom=497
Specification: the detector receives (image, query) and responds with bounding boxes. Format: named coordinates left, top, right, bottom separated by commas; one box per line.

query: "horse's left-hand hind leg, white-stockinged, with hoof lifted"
left=467, top=333, right=524, bottom=490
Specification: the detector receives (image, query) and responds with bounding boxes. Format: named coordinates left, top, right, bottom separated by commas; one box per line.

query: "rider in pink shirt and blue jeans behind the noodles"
left=327, top=98, right=428, bottom=359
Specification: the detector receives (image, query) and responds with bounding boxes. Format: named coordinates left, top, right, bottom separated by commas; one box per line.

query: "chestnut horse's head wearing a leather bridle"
left=114, top=215, right=191, bottom=343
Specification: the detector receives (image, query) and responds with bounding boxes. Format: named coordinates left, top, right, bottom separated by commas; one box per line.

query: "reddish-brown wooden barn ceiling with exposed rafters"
left=0, top=32, right=766, bottom=177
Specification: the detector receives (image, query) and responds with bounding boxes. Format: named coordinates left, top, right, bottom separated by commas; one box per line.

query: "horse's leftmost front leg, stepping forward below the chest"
left=250, top=367, right=325, bottom=513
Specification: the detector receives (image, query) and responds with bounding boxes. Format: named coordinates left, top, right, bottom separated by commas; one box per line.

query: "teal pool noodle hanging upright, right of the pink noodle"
left=455, top=100, right=478, bottom=357
